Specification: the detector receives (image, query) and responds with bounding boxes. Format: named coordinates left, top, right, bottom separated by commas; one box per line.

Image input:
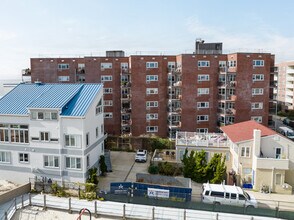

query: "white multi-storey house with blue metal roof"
left=0, top=83, right=106, bottom=183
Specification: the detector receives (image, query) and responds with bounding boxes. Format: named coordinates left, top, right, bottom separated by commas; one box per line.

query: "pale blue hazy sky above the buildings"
left=0, top=0, right=294, bottom=80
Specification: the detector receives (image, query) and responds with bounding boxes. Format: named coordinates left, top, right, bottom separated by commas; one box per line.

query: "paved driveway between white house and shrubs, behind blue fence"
left=98, top=151, right=151, bottom=191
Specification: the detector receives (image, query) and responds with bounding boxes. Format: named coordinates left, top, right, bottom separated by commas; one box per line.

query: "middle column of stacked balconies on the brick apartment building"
left=167, top=65, right=182, bottom=140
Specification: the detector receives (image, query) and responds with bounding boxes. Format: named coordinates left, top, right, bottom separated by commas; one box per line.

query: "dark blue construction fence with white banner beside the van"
left=110, top=182, right=192, bottom=202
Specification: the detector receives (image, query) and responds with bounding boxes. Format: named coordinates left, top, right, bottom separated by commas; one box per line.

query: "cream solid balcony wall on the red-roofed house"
left=256, top=158, right=289, bottom=170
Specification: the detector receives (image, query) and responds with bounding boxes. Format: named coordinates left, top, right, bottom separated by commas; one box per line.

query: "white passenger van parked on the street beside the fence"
left=202, top=183, right=257, bottom=208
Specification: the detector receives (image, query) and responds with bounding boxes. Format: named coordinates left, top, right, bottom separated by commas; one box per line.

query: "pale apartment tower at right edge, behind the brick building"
left=277, top=61, right=294, bottom=110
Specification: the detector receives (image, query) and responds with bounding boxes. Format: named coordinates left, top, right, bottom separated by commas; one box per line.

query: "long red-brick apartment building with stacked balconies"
left=24, top=45, right=275, bottom=141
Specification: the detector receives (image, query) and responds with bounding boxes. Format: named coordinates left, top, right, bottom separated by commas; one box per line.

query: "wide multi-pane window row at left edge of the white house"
left=7, top=124, right=29, bottom=143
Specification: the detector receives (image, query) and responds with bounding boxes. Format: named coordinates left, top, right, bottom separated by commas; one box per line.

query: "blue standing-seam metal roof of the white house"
left=0, top=83, right=102, bottom=116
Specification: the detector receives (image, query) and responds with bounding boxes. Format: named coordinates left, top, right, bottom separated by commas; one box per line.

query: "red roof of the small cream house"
left=221, top=120, right=277, bottom=143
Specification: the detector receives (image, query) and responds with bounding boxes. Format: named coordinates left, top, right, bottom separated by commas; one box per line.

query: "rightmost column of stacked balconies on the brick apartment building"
left=218, top=66, right=237, bottom=127
